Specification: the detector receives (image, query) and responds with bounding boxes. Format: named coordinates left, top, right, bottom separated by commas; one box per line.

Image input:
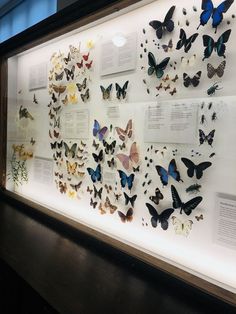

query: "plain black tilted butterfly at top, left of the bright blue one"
left=149, top=6, right=175, bottom=39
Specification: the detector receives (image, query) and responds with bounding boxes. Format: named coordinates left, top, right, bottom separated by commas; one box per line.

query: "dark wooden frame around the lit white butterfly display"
left=0, top=0, right=236, bottom=306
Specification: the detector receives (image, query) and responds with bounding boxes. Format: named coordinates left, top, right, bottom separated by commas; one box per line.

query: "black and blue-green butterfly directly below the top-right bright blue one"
left=202, top=29, right=231, bottom=61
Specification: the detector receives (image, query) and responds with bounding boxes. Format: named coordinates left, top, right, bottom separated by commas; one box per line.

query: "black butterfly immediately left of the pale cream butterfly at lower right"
left=146, top=203, right=174, bottom=230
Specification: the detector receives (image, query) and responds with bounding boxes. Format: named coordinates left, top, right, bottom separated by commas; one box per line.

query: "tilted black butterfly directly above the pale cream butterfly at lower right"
left=171, top=185, right=202, bottom=216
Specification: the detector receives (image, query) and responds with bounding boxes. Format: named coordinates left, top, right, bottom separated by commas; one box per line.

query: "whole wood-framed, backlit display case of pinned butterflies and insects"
left=1, top=0, right=236, bottom=305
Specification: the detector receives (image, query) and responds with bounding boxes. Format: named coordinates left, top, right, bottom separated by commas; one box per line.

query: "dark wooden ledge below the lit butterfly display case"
left=0, top=200, right=236, bottom=314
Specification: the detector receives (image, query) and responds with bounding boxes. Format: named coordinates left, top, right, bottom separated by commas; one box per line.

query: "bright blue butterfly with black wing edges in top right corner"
left=197, top=0, right=234, bottom=33
